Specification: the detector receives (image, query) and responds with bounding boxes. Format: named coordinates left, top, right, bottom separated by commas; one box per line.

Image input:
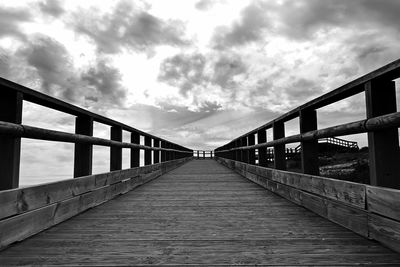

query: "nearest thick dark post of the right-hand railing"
left=365, top=80, right=400, bottom=188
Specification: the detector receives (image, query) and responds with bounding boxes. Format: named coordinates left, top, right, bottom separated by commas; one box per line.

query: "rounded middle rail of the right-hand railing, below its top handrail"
left=217, top=112, right=400, bottom=152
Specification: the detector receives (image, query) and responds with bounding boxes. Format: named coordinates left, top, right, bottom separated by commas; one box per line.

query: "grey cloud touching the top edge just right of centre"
left=212, top=2, right=269, bottom=49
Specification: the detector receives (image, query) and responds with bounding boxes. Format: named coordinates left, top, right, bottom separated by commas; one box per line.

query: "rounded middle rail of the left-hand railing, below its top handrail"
left=0, top=121, right=193, bottom=154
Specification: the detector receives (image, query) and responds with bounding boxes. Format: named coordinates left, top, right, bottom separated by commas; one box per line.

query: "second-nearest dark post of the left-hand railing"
left=74, top=116, right=93, bottom=177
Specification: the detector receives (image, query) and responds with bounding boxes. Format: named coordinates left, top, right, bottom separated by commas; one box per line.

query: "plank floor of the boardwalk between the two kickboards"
left=0, top=160, right=400, bottom=266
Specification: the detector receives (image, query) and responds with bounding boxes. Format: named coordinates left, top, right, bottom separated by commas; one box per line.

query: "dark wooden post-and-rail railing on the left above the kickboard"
left=0, top=78, right=193, bottom=190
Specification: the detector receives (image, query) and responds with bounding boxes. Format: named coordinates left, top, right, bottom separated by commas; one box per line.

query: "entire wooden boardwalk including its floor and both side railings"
left=0, top=60, right=400, bottom=266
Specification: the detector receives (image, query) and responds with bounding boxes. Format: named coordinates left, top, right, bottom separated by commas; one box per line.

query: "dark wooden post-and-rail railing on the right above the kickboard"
left=215, top=60, right=400, bottom=188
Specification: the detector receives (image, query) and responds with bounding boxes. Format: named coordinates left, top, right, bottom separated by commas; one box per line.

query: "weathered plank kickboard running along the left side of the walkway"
left=0, top=159, right=192, bottom=249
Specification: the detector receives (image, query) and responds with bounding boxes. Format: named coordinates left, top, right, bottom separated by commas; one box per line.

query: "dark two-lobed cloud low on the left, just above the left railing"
left=18, top=36, right=126, bottom=105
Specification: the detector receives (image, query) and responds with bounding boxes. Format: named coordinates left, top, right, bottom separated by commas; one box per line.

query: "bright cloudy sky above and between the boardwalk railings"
left=0, top=0, right=400, bottom=184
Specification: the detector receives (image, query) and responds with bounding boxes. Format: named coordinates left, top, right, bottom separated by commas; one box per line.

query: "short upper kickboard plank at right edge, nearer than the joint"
left=367, top=186, right=400, bottom=221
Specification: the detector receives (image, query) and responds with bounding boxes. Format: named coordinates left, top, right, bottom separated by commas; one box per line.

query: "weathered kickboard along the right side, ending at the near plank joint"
left=220, top=159, right=370, bottom=242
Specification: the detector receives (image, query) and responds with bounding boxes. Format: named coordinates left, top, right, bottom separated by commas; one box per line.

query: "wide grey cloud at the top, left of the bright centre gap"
left=75, top=2, right=189, bottom=54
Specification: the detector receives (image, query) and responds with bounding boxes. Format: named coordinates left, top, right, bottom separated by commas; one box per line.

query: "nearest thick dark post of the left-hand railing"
left=0, top=90, right=23, bottom=190
